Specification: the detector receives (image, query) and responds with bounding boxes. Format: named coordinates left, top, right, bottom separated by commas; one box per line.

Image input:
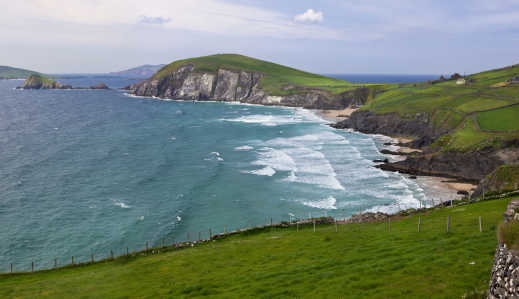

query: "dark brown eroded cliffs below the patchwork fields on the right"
left=332, top=110, right=519, bottom=184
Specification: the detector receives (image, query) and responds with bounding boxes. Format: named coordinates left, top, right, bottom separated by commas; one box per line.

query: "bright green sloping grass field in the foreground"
left=0, top=200, right=508, bottom=298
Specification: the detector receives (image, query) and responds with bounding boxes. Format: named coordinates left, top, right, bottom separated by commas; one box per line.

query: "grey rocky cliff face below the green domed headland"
left=126, top=64, right=369, bottom=109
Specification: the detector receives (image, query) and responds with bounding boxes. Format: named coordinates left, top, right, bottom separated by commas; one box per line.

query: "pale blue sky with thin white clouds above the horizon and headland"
left=0, top=0, right=519, bottom=74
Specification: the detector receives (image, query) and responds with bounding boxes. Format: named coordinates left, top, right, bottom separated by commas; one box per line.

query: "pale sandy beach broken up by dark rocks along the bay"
left=310, top=108, right=477, bottom=203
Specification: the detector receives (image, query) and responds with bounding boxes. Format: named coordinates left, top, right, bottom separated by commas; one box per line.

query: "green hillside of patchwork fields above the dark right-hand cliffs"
left=363, top=65, right=519, bottom=150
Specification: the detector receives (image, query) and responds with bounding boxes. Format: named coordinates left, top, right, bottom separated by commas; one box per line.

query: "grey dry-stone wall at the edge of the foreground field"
left=488, top=199, right=519, bottom=299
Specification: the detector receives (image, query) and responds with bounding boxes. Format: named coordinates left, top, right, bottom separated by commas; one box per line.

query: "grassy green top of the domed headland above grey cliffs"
left=153, top=54, right=355, bottom=95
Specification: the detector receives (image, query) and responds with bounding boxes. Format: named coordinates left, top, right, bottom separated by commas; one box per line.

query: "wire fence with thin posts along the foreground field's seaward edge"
left=4, top=203, right=496, bottom=273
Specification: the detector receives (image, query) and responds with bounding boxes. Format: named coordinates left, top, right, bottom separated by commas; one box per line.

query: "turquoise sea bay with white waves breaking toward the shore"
left=0, top=79, right=436, bottom=272
